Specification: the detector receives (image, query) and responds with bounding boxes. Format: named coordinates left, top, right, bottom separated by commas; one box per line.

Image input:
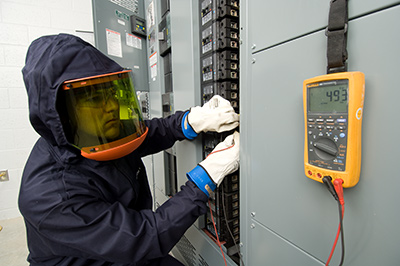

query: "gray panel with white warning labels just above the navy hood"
left=92, top=0, right=149, bottom=93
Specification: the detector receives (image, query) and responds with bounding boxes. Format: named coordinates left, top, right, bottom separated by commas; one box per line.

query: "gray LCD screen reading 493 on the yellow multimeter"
left=308, top=80, right=348, bottom=113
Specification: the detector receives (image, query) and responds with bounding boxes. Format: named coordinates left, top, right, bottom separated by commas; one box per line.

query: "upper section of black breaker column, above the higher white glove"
left=199, top=0, right=239, bottom=112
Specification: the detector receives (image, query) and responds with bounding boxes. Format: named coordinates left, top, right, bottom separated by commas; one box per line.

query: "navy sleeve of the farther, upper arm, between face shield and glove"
left=138, top=111, right=186, bottom=157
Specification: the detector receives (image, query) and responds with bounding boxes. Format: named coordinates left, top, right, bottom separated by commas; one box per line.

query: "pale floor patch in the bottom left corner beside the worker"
left=0, top=217, right=29, bottom=266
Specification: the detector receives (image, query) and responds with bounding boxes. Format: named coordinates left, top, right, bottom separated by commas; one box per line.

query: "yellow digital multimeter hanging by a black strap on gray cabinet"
left=303, top=72, right=365, bottom=187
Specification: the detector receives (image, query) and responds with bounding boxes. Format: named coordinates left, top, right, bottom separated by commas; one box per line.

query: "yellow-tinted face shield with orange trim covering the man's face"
left=61, top=70, right=148, bottom=161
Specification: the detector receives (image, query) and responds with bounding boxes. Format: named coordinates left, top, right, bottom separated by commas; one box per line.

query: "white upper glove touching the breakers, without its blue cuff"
left=187, top=95, right=239, bottom=134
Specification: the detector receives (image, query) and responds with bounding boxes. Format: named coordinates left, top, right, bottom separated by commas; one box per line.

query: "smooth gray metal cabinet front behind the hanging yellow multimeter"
left=241, top=0, right=400, bottom=265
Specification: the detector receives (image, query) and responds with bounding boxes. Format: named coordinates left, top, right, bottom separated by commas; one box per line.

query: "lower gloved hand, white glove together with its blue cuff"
left=186, top=131, right=240, bottom=196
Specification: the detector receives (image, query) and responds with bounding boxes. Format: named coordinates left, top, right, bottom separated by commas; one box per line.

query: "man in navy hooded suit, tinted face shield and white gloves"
left=19, top=34, right=239, bottom=266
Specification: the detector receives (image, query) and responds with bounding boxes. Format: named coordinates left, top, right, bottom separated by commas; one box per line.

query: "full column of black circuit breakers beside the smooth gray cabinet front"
left=199, top=0, right=240, bottom=262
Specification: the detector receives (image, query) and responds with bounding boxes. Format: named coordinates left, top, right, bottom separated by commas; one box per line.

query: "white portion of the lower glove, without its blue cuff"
left=199, top=131, right=240, bottom=186
